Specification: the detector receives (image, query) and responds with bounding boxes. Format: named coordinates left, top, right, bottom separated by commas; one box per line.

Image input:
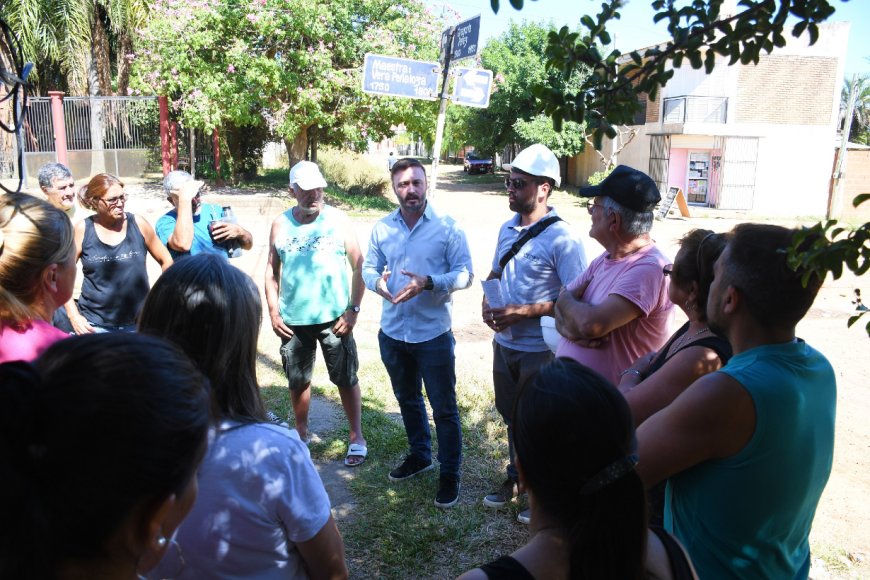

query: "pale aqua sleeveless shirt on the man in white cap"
left=274, top=205, right=350, bottom=326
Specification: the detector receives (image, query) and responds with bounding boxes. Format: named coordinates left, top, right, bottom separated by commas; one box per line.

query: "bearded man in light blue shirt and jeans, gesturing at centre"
left=363, top=159, right=474, bottom=508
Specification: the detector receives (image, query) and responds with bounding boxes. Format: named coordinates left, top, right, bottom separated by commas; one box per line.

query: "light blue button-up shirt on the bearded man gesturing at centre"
left=363, top=203, right=474, bottom=343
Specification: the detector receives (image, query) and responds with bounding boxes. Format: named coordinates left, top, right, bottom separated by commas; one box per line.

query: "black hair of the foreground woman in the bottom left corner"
left=0, top=333, right=211, bottom=579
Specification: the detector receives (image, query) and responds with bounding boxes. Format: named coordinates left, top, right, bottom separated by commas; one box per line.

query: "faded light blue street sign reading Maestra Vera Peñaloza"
left=363, top=54, right=440, bottom=101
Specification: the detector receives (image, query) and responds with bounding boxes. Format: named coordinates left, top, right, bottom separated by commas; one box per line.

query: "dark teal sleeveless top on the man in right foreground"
left=665, top=340, right=837, bottom=580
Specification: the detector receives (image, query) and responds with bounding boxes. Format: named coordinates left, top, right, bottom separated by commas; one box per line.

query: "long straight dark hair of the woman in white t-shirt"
left=139, top=254, right=266, bottom=422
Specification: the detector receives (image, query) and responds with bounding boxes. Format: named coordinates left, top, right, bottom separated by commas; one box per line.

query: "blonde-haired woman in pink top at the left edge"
left=0, top=193, right=76, bottom=363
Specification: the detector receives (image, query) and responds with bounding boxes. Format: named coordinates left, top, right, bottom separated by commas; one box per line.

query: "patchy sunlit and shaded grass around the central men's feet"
left=258, top=338, right=528, bottom=578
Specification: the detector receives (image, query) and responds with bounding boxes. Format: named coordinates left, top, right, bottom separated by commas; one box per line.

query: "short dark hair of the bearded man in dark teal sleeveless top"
left=722, top=223, right=823, bottom=328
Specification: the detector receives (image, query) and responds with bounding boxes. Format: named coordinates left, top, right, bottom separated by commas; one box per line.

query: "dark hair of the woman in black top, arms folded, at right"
left=671, top=229, right=726, bottom=322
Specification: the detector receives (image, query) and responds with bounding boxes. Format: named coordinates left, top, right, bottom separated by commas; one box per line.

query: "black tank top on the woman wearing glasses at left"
left=78, top=213, right=148, bottom=326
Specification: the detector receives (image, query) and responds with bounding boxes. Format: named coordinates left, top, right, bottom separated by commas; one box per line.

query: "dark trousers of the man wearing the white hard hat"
left=492, top=341, right=553, bottom=481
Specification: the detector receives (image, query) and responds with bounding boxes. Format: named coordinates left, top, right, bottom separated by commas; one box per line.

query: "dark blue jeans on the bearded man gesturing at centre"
left=378, top=331, right=462, bottom=478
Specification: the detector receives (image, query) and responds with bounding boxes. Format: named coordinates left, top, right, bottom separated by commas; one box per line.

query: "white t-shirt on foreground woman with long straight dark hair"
left=172, top=421, right=330, bottom=580
